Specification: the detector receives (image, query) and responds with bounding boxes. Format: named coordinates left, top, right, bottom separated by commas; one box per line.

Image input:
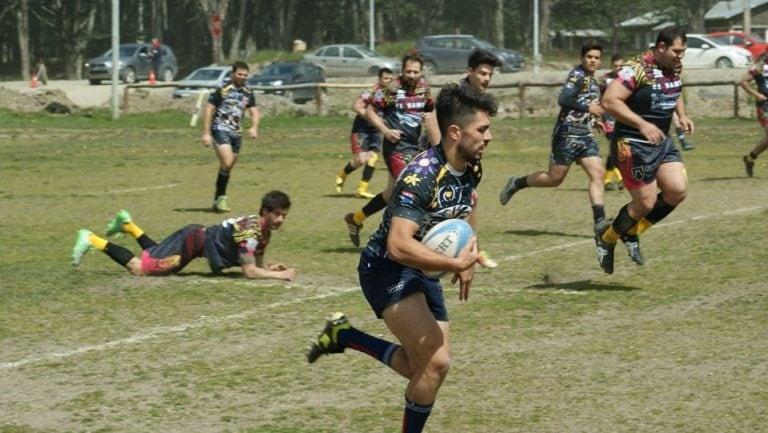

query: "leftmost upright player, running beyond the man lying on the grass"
left=203, top=61, right=260, bottom=212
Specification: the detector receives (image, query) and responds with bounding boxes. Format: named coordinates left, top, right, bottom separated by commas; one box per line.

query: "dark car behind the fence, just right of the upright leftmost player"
left=247, top=62, right=325, bottom=104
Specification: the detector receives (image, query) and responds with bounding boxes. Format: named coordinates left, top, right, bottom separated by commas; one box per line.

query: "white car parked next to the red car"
left=683, top=34, right=752, bottom=68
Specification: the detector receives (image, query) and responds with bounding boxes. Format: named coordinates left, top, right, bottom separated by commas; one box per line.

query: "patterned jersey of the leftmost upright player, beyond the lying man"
left=208, top=82, right=256, bottom=134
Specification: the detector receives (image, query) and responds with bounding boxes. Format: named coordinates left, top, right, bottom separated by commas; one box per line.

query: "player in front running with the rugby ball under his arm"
left=307, top=84, right=496, bottom=433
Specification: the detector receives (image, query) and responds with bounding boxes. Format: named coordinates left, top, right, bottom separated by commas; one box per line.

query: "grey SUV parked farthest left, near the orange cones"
left=85, top=44, right=179, bottom=84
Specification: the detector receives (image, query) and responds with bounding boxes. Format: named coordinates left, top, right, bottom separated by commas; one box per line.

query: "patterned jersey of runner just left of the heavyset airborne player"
left=552, top=65, right=600, bottom=136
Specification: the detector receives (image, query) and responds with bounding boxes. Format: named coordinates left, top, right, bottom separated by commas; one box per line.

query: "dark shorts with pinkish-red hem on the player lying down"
left=141, top=224, right=205, bottom=275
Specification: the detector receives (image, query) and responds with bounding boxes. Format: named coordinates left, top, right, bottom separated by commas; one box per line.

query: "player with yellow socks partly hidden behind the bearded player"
left=336, top=68, right=392, bottom=199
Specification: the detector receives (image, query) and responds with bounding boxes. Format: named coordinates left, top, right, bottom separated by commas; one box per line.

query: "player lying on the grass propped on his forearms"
left=72, top=191, right=296, bottom=281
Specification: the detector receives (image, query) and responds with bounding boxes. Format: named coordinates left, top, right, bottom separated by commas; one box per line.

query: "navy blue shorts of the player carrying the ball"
left=357, top=248, right=448, bottom=322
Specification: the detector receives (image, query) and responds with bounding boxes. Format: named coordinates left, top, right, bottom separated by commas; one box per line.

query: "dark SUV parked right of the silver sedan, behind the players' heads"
left=416, top=35, right=525, bottom=75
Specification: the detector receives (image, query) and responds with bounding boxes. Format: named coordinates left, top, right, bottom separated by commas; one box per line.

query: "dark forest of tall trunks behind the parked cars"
left=0, top=0, right=715, bottom=79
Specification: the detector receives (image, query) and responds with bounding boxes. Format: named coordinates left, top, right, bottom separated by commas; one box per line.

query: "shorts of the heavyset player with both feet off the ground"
left=611, top=136, right=683, bottom=189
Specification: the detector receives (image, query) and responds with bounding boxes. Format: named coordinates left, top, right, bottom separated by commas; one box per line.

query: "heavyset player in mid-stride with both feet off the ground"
left=595, top=27, right=693, bottom=274
